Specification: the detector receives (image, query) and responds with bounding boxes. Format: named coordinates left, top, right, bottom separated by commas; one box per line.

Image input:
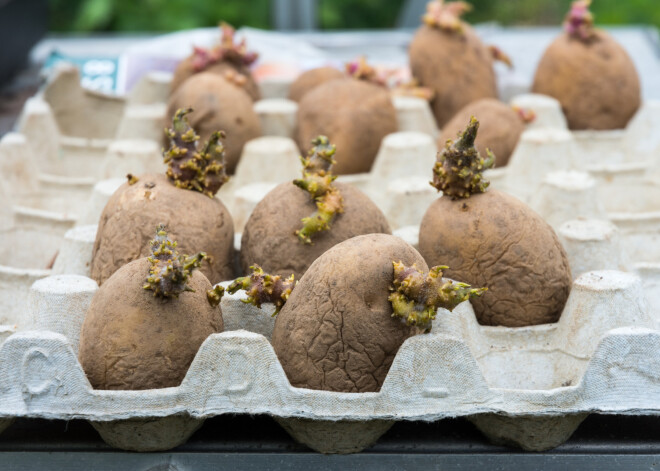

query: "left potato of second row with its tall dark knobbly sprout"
left=91, top=109, right=234, bottom=285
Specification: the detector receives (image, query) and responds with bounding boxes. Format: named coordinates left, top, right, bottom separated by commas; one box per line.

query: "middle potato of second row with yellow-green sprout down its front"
left=241, top=136, right=391, bottom=279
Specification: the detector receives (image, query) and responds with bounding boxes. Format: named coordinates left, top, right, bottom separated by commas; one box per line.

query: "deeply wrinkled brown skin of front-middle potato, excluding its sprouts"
left=272, top=234, right=428, bottom=392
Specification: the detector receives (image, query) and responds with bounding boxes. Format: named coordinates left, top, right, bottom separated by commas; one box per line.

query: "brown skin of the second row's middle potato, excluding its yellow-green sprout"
left=241, top=182, right=391, bottom=280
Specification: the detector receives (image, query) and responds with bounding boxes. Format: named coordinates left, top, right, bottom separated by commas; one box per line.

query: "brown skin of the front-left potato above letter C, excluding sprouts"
left=78, top=258, right=223, bottom=390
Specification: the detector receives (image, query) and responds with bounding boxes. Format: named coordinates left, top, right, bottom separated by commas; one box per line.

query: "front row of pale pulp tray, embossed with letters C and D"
left=0, top=260, right=660, bottom=453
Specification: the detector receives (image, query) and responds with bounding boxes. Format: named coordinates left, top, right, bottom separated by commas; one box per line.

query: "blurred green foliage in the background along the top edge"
left=49, top=0, right=660, bottom=32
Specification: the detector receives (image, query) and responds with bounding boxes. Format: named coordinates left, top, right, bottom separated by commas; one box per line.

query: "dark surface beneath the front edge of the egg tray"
left=0, top=415, right=660, bottom=471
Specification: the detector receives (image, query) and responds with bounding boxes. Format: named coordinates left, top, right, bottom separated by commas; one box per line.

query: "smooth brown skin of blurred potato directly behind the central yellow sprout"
left=296, top=78, right=398, bottom=175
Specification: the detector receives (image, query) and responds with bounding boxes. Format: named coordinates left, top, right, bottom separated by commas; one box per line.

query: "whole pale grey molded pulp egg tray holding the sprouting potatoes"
left=0, top=68, right=660, bottom=453
